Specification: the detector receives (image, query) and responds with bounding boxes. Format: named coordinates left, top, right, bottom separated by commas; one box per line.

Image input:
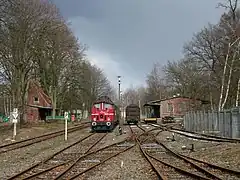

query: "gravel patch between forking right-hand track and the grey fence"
left=158, top=131, right=240, bottom=171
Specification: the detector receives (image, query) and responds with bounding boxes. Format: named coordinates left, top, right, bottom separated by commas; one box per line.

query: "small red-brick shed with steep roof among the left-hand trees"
left=26, top=81, right=52, bottom=122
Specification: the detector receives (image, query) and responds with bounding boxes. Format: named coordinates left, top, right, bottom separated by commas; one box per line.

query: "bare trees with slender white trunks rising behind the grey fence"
left=181, top=5, right=240, bottom=111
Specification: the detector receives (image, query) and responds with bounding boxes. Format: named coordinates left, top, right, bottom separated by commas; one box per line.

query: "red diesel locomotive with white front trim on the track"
left=91, top=96, right=119, bottom=131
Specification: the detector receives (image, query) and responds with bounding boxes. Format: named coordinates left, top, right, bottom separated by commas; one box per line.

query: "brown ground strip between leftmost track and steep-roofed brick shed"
left=0, top=122, right=83, bottom=144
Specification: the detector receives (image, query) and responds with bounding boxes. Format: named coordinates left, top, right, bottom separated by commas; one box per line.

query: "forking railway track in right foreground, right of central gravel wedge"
left=132, top=125, right=240, bottom=180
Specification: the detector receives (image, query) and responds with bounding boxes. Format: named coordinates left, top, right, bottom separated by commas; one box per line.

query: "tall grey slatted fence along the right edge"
left=184, top=108, right=240, bottom=138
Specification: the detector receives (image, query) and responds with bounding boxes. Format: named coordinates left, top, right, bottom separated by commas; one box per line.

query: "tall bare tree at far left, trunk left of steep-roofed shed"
left=0, top=0, right=64, bottom=124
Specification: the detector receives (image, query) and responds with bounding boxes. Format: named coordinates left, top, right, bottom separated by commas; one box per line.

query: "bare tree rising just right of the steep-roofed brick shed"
left=33, top=21, right=84, bottom=117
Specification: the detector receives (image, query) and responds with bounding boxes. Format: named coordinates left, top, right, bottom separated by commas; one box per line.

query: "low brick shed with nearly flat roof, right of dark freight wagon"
left=160, top=96, right=208, bottom=117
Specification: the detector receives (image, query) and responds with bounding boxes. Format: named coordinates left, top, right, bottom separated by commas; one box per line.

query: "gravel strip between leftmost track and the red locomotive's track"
left=0, top=128, right=89, bottom=179
